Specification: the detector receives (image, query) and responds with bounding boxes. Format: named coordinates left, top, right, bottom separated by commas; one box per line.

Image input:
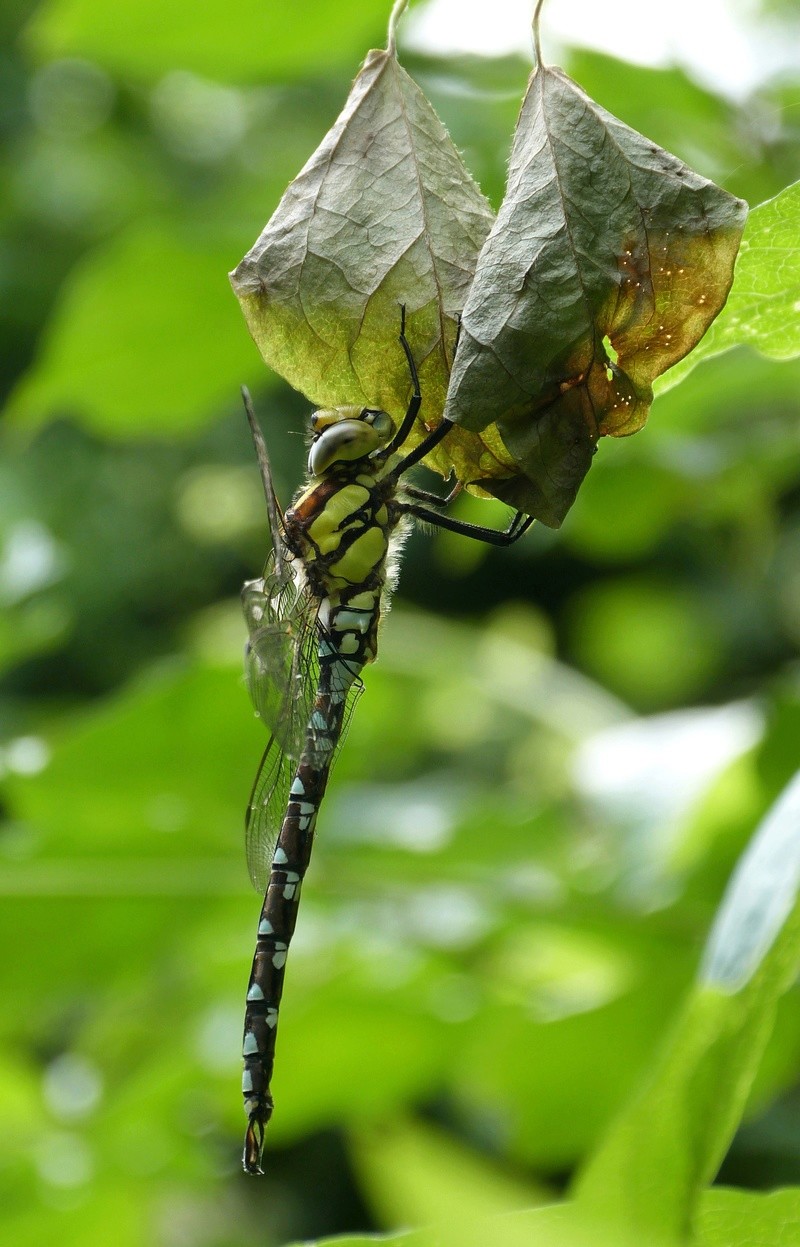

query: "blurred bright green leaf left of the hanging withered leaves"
left=9, top=223, right=261, bottom=434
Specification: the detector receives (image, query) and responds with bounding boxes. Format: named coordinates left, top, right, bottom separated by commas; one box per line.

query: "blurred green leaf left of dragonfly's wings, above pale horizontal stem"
left=9, top=662, right=251, bottom=852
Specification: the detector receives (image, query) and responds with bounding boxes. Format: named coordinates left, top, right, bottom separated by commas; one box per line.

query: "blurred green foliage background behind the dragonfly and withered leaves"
left=0, top=0, right=800, bottom=1247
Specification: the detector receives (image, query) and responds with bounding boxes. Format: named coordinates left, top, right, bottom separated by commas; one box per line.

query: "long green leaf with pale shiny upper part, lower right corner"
left=577, top=774, right=800, bottom=1242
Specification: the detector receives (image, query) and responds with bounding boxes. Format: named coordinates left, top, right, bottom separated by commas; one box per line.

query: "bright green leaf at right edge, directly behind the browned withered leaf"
left=658, top=182, right=800, bottom=393
